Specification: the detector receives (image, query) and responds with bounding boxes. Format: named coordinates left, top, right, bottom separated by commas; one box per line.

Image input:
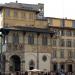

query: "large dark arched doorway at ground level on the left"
left=9, top=55, right=21, bottom=71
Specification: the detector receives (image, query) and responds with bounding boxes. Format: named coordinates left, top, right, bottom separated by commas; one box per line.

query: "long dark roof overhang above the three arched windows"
left=0, top=27, right=55, bottom=35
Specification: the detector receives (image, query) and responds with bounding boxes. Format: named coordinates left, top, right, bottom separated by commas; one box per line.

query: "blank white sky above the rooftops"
left=0, top=0, right=75, bottom=19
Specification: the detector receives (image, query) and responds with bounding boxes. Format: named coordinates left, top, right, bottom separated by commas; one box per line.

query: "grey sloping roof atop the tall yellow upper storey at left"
left=0, top=2, right=39, bottom=12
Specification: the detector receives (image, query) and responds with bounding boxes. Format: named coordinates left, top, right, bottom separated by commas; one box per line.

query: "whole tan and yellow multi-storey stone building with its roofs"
left=0, top=2, right=75, bottom=72
